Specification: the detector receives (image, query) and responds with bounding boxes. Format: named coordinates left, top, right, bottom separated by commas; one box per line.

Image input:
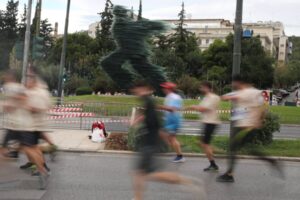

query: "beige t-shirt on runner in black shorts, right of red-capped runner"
left=200, top=93, right=220, bottom=124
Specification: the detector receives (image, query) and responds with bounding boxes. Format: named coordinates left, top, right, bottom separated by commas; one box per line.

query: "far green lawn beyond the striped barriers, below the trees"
left=65, top=95, right=300, bottom=125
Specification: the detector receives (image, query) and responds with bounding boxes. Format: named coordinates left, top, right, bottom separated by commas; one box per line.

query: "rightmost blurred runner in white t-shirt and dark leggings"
left=217, top=76, right=282, bottom=182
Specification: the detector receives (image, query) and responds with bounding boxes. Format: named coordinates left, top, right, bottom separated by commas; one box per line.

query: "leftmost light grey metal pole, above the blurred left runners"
left=22, top=0, right=32, bottom=84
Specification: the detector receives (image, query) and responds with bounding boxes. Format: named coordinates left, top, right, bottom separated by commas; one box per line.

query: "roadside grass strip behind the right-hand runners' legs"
left=179, top=136, right=300, bottom=157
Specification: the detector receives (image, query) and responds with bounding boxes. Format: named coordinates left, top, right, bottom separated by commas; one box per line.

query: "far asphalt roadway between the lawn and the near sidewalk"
left=49, top=118, right=300, bottom=139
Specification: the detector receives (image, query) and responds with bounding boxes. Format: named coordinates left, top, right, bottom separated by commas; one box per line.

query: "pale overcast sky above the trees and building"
left=0, top=0, right=300, bottom=36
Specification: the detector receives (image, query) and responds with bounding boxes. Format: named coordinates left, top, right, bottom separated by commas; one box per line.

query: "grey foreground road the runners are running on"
left=0, top=153, right=300, bottom=200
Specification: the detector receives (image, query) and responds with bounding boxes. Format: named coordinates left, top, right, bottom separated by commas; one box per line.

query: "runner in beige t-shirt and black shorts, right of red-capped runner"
left=185, top=81, right=220, bottom=171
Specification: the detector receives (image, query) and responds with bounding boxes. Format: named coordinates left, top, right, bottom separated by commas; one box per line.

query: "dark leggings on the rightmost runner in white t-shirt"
left=227, top=128, right=276, bottom=174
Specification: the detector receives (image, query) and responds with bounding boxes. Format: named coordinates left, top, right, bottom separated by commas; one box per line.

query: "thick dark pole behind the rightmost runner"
left=230, top=0, right=243, bottom=137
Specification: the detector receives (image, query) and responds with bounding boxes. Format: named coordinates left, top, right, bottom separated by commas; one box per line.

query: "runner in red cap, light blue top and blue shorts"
left=158, top=82, right=185, bottom=163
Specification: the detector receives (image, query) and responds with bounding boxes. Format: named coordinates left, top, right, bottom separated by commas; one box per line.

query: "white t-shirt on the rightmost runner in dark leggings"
left=232, top=87, right=264, bottom=127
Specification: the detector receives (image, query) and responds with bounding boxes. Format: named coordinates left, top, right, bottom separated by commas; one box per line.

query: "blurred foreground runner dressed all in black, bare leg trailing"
left=132, top=82, right=205, bottom=200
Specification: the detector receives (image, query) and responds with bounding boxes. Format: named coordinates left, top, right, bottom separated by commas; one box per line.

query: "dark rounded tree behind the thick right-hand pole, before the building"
left=203, top=34, right=274, bottom=88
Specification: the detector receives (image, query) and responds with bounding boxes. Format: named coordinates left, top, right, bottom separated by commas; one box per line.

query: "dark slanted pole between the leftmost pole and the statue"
left=57, top=0, right=71, bottom=105
